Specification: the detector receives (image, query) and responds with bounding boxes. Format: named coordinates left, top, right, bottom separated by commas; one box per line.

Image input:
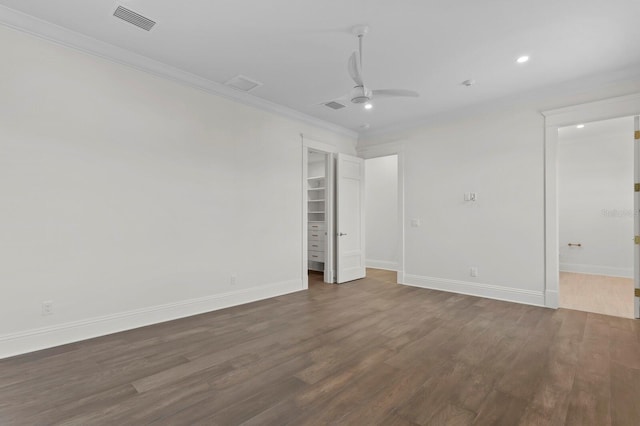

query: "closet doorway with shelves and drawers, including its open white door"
left=302, top=136, right=366, bottom=289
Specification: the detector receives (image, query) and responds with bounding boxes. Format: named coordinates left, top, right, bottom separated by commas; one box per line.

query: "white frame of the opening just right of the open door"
left=357, top=141, right=405, bottom=284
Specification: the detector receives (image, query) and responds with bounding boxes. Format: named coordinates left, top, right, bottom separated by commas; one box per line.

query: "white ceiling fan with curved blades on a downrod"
left=324, top=25, right=420, bottom=109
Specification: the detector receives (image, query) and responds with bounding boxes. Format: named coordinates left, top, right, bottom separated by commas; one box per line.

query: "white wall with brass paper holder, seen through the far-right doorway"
left=557, top=117, right=634, bottom=278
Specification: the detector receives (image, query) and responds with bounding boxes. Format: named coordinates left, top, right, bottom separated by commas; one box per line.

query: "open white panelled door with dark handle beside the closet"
left=336, top=154, right=367, bottom=284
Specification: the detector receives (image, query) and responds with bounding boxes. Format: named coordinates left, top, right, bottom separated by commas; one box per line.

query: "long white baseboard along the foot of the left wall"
left=0, top=280, right=303, bottom=359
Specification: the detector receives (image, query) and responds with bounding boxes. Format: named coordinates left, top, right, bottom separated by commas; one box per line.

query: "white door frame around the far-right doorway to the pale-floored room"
left=541, top=93, right=640, bottom=308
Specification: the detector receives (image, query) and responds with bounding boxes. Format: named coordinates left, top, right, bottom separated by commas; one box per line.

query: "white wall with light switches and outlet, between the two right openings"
left=358, top=78, right=640, bottom=305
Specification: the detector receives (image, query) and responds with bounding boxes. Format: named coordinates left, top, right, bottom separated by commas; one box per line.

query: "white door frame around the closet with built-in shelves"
left=300, top=134, right=338, bottom=290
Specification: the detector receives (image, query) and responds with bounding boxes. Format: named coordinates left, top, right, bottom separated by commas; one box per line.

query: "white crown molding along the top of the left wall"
left=0, top=6, right=358, bottom=139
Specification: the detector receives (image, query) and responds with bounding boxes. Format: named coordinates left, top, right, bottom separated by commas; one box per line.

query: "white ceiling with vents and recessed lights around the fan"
left=0, top=0, right=640, bottom=135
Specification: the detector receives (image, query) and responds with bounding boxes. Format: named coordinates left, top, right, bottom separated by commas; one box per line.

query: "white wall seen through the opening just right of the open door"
left=365, top=155, right=400, bottom=270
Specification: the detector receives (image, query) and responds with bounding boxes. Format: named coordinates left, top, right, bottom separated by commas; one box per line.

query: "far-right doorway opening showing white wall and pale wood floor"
left=557, top=117, right=634, bottom=318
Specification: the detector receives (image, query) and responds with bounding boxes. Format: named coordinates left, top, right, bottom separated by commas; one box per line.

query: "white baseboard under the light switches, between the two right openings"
left=401, top=274, right=545, bottom=306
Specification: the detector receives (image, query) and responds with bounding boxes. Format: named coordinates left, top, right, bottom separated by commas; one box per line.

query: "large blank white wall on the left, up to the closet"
left=0, top=27, right=355, bottom=357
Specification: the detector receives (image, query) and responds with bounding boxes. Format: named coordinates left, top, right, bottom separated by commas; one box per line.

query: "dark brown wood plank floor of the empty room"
left=0, top=271, right=640, bottom=426
